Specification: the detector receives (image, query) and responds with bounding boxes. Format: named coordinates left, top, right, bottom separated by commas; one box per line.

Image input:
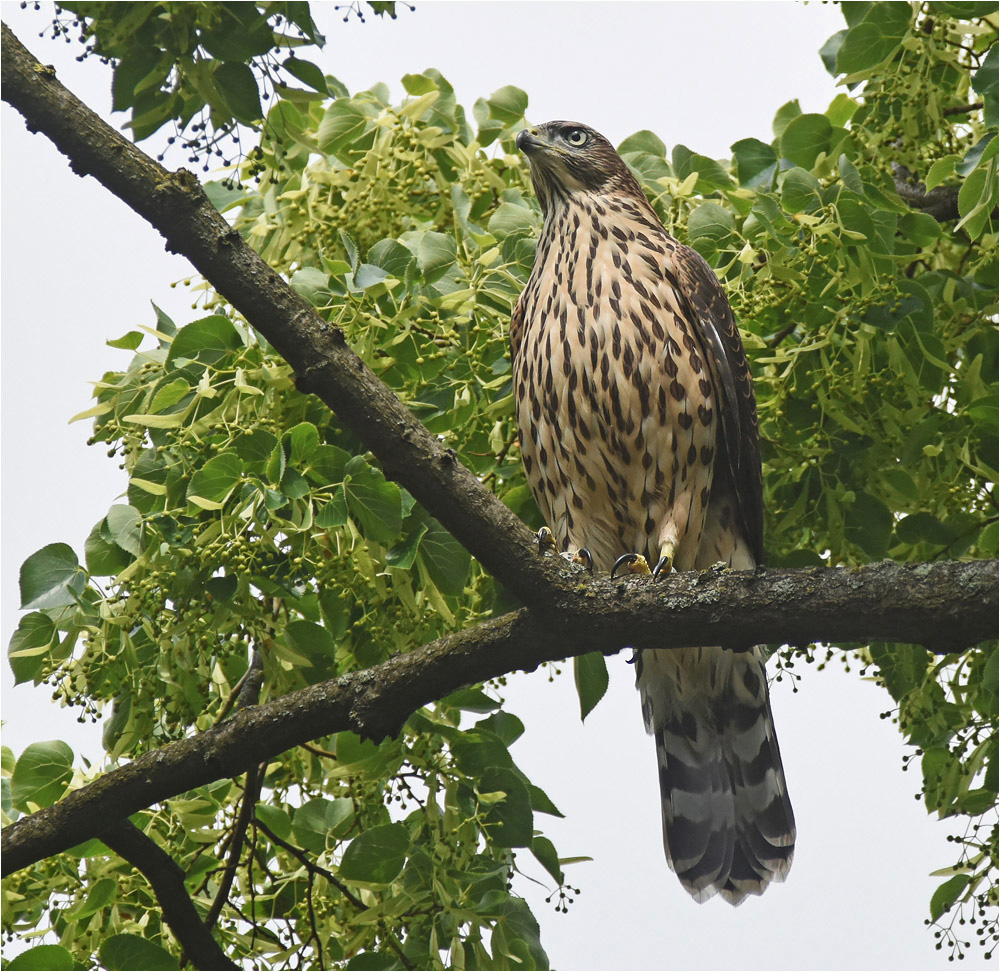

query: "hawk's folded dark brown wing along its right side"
left=673, top=246, right=764, bottom=564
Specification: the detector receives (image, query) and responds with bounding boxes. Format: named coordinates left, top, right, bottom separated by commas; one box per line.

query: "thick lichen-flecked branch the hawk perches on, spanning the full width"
left=3, top=561, right=997, bottom=874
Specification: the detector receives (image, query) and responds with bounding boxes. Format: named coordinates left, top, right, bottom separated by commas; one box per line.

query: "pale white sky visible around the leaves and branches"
left=2, top=0, right=987, bottom=970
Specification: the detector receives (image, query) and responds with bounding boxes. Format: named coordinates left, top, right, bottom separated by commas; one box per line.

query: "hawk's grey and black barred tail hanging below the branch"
left=637, top=648, right=795, bottom=905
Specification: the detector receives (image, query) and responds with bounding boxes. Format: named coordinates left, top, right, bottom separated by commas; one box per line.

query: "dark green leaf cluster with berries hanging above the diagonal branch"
left=37, top=0, right=396, bottom=172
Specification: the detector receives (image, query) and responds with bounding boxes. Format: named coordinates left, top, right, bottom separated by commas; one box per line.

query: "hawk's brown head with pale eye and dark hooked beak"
left=517, top=121, right=638, bottom=210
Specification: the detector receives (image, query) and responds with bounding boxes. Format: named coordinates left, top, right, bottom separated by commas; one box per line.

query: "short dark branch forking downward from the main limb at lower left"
left=99, top=820, right=240, bottom=969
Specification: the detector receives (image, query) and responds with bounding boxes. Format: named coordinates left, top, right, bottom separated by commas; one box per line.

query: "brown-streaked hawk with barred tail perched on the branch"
left=510, top=121, right=795, bottom=904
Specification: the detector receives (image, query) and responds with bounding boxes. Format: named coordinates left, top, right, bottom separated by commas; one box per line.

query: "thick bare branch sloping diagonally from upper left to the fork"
left=0, top=24, right=554, bottom=605
